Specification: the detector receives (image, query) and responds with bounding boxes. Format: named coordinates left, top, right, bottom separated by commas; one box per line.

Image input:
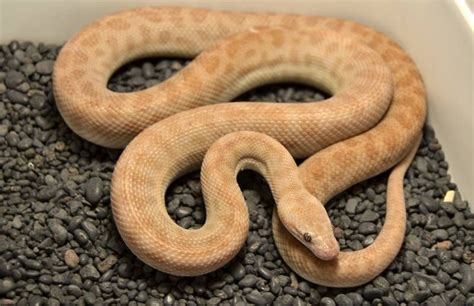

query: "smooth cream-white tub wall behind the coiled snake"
left=0, top=0, right=474, bottom=207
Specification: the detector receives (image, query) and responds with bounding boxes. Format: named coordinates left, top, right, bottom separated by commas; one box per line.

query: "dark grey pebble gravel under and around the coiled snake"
left=0, top=41, right=474, bottom=305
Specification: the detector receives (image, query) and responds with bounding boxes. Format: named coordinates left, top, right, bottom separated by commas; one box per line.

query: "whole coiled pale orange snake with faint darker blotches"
left=53, top=7, right=426, bottom=287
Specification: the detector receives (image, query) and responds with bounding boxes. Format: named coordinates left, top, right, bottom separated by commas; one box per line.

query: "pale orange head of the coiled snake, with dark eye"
left=278, top=198, right=339, bottom=260
